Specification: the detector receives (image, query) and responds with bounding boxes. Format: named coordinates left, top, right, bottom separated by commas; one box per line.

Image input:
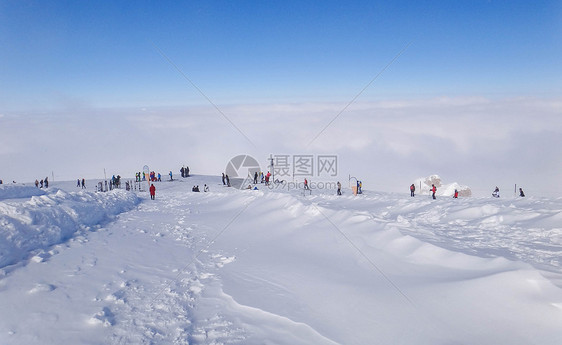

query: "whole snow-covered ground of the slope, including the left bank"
left=0, top=176, right=562, bottom=345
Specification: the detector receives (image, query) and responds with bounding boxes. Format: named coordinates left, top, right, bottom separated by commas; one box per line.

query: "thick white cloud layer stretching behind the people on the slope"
left=0, top=98, right=562, bottom=193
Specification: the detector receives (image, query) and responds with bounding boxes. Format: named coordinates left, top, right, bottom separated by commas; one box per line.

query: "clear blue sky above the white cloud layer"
left=0, top=1, right=562, bottom=112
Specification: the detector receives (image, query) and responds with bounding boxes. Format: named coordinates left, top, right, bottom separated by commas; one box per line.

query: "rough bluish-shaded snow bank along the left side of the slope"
left=0, top=185, right=140, bottom=268
